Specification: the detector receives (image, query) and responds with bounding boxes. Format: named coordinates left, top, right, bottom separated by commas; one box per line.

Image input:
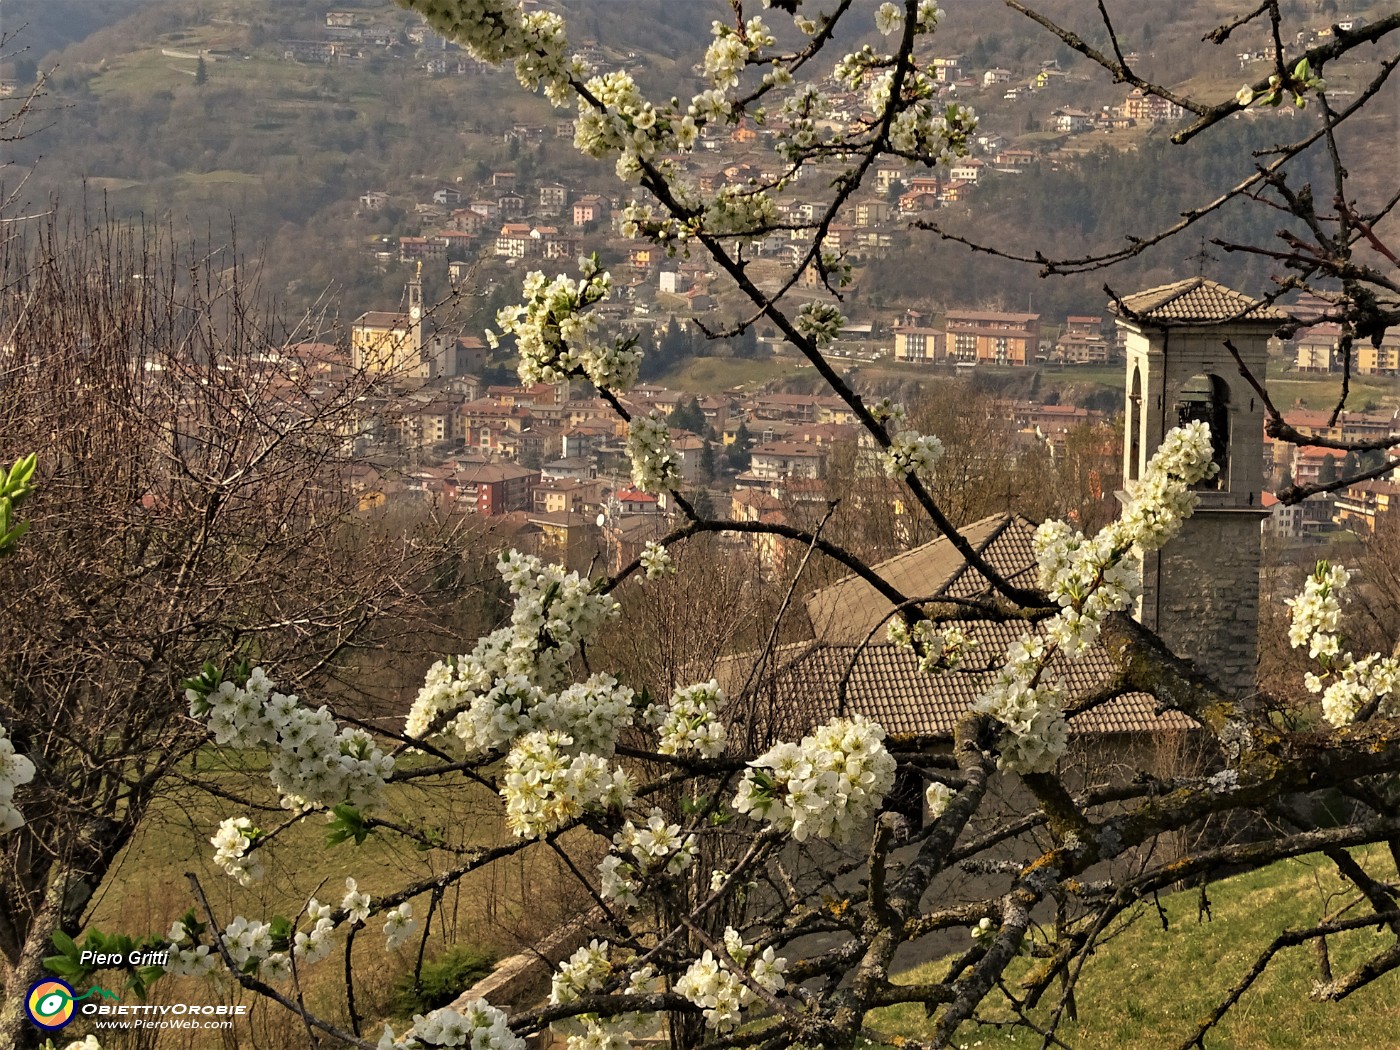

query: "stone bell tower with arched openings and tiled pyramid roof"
left=1110, top=277, right=1287, bottom=696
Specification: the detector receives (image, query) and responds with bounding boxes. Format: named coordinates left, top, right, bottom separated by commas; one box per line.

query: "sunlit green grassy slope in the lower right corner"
left=875, top=857, right=1400, bottom=1050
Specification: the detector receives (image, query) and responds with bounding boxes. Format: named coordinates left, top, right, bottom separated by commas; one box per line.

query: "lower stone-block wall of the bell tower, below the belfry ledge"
left=1141, top=510, right=1260, bottom=696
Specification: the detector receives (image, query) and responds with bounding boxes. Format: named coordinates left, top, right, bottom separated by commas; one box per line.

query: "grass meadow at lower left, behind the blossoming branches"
left=74, top=749, right=587, bottom=1050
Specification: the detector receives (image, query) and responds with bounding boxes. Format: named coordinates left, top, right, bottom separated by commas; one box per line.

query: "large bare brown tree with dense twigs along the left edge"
left=0, top=220, right=453, bottom=1047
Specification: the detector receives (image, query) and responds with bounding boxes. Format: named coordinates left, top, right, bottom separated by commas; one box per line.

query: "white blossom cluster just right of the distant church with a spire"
left=493, top=256, right=641, bottom=391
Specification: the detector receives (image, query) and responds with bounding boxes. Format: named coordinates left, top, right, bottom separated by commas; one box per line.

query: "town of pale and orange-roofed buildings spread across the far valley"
left=226, top=0, right=1400, bottom=567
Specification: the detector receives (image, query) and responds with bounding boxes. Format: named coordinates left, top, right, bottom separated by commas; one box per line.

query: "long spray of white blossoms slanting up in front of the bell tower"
left=974, top=423, right=1218, bottom=773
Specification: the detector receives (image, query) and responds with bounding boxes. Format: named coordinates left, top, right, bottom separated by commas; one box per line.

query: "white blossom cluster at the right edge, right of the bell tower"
left=1287, top=561, right=1400, bottom=727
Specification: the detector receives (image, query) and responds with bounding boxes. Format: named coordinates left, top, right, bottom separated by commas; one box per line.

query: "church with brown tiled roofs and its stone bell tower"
left=731, top=277, right=1285, bottom=755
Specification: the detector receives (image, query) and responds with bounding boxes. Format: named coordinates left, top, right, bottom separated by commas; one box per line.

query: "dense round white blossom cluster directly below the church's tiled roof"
left=734, top=715, right=895, bottom=841
